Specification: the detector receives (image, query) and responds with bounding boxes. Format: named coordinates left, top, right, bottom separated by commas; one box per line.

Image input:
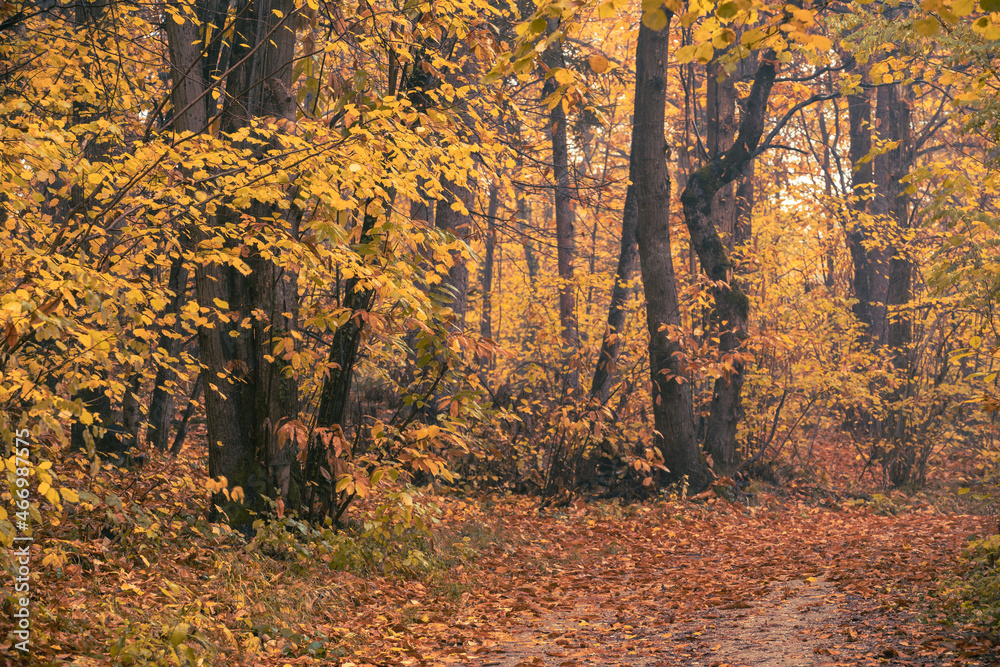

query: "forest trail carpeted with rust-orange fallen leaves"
left=372, top=500, right=995, bottom=667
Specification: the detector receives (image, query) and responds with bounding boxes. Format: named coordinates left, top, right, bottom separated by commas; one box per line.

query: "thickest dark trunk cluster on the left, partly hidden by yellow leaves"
left=165, top=0, right=300, bottom=530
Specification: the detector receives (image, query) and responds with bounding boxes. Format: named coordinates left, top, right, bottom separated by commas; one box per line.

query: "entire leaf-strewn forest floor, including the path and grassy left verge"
left=7, top=438, right=1000, bottom=667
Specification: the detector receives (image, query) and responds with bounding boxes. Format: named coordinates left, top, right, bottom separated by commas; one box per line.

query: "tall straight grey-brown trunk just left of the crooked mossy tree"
left=629, top=10, right=707, bottom=489
